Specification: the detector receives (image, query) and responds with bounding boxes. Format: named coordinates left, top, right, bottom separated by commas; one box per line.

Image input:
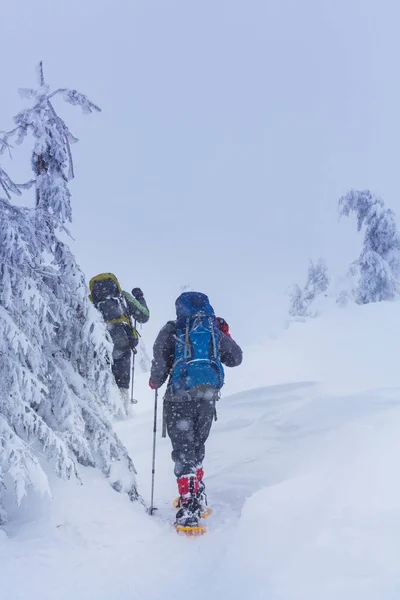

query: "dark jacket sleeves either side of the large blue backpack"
left=150, top=321, right=243, bottom=388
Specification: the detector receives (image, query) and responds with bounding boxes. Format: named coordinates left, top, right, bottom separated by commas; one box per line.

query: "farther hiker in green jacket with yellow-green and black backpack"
left=89, top=273, right=150, bottom=412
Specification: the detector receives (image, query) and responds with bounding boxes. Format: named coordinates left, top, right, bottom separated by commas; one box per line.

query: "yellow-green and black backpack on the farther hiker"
left=89, top=273, right=139, bottom=352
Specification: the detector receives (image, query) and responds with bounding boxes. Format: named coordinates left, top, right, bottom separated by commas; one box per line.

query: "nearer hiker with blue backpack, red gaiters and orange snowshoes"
left=149, top=292, right=242, bottom=531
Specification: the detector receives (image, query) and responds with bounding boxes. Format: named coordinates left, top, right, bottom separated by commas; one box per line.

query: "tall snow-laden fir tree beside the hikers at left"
left=0, top=66, right=141, bottom=521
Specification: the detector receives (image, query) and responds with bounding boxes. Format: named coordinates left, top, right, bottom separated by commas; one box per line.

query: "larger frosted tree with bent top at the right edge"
left=339, top=190, right=400, bottom=304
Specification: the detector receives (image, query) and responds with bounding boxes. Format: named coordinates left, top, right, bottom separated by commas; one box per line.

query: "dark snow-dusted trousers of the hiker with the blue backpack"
left=164, top=388, right=218, bottom=479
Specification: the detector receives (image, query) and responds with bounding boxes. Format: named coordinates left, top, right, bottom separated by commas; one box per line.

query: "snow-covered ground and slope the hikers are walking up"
left=0, top=303, right=400, bottom=600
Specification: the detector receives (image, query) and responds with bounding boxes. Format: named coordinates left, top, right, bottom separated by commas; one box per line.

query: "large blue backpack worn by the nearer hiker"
left=171, top=292, right=224, bottom=392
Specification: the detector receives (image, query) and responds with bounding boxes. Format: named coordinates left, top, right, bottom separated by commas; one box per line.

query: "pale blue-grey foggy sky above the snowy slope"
left=0, top=0, right=400, bottom=345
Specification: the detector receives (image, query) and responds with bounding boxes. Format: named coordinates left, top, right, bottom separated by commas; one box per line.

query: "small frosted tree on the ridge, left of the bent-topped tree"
left=289, top=258, right=329, bottom=317
